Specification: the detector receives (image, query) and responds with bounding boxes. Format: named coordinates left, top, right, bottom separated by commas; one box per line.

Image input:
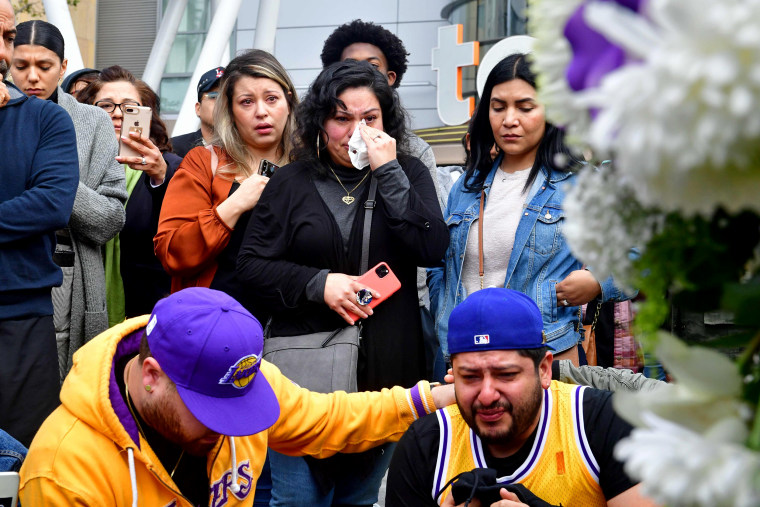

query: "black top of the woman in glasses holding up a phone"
left=119, top=153, right=182, bottom=318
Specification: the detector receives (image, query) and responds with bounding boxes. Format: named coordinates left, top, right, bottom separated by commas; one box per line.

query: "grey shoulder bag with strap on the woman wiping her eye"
left=263, top=177, right=377, bottom=393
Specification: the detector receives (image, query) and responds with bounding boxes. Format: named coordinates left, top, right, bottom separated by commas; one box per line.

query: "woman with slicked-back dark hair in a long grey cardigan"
left=11, top=20, right=127, bottom=378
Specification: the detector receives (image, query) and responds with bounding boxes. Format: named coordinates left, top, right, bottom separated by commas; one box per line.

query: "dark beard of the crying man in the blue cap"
left=457, top=377, right=544, bottom=445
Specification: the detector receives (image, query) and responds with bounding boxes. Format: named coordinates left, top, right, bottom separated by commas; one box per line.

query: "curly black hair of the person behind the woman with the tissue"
left=321, top=19, right=409, bottom=88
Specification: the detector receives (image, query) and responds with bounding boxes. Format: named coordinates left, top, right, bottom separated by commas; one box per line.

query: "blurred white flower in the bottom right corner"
left=615, top=412, right=760, bottom=507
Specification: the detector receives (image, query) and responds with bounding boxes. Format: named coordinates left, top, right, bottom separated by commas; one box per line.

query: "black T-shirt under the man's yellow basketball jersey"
left=385, top=388, right=636, bottom=507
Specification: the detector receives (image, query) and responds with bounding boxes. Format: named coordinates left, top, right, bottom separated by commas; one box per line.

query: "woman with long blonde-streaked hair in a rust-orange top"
left=154, top=49, right=298, bottom=318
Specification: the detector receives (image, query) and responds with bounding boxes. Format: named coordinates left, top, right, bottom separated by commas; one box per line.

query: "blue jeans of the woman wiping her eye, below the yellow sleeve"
left=269, top=443, right=396, bottom=507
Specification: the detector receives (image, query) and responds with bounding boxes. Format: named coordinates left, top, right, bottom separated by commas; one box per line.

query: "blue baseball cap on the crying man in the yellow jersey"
left=448, top=288, right=551, bottom=354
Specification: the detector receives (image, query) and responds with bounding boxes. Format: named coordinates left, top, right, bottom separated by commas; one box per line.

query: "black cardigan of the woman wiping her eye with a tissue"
left=238, top=158, right=449, bottom=390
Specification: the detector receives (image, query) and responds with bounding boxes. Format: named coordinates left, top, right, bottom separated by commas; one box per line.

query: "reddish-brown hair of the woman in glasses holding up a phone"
left=76, top=65, right=172, bottom=153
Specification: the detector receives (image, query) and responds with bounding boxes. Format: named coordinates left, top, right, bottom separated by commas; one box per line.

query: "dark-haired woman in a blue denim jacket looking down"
left=428, top=54, right=626, bottom=365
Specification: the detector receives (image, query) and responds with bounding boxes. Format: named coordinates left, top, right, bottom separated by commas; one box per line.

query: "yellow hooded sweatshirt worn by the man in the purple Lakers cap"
left=20, top=315, right=435, bottom=507
